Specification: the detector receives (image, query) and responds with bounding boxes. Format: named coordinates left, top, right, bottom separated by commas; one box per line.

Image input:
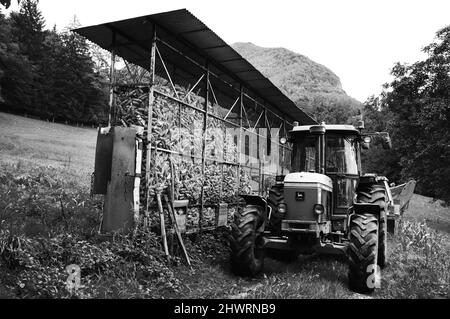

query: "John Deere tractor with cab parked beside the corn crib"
left=230, top=122, right=399, bottom=293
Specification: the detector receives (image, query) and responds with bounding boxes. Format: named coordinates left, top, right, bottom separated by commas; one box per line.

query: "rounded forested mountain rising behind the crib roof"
left=232, top=42, right=362, bottom=124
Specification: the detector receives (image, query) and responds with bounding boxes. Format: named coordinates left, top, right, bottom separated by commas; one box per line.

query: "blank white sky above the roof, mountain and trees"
left=3, top=0, right=450, bottom=102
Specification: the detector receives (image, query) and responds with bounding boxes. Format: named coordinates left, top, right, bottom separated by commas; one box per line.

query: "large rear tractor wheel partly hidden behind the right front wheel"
left=356, top=184, right=388, bottom=268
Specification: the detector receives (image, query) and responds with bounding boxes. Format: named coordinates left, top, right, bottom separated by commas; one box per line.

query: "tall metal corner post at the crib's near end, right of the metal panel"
left=145, top=25, right=156, bottom=223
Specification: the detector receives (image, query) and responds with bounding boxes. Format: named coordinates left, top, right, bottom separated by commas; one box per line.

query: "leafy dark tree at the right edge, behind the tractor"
left=365, top=26, right=450, bottom=202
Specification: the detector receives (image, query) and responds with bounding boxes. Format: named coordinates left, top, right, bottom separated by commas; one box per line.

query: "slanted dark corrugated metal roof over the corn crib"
left=73, top=9, right=317, bottom=124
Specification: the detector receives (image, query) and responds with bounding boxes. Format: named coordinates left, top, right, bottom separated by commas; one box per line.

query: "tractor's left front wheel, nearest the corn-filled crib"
left=230, top=205, right=265, bottom=276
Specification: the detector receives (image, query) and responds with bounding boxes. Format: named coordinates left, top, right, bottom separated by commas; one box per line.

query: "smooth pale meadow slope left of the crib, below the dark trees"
left=0, top=112, right=97, bottom=186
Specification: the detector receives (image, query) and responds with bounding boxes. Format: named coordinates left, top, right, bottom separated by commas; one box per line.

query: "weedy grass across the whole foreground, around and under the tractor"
left=0, top=161, right=450, bottom=298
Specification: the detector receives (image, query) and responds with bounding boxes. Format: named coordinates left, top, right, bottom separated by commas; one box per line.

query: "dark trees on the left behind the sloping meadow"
left=0, top=0, right=108, bottom=124
